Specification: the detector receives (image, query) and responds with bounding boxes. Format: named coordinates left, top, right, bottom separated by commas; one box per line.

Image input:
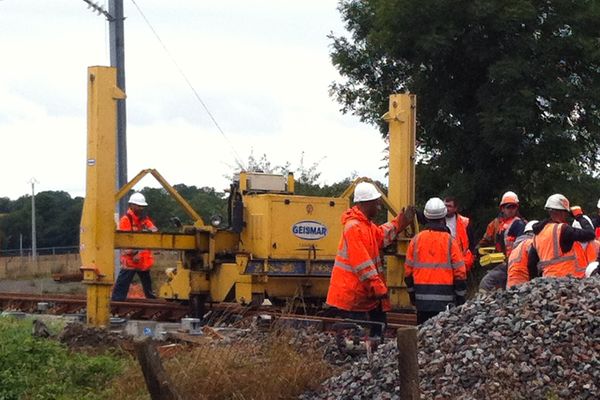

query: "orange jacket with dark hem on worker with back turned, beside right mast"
left=404, top=230, right=467, bottom=311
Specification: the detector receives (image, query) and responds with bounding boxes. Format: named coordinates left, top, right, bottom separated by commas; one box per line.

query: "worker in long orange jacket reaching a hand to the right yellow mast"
left=326, top=182, right=415, bottom=335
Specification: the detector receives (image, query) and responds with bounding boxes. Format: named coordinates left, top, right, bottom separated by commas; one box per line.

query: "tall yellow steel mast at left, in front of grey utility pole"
left=80, top=67, right=125, bottom=327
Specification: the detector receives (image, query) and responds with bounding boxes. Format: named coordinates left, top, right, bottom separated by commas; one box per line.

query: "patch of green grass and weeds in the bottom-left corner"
left=0, top=318, right=124, bottom=400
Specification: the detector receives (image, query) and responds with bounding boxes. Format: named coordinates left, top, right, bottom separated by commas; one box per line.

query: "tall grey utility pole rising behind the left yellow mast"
left=108, top=0, right=127, bottom=216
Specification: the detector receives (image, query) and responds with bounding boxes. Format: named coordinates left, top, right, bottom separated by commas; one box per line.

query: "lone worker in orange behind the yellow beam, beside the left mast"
left=111, top=192, right=158, bottom=301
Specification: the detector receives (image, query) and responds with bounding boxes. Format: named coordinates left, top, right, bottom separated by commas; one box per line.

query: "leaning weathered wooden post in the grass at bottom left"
left=134, top=337, right=181, bottom=400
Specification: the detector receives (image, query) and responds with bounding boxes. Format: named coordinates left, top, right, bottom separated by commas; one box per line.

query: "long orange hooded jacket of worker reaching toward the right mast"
left=327, top=206, right=398, bottom=311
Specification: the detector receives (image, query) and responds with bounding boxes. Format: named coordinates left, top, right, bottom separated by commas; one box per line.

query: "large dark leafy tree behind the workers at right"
left=331, top=0, right=600, bottom=230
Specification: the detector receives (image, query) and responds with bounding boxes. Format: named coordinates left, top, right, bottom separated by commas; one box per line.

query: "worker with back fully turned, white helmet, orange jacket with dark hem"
left=404, top=197, right=467, bottom=324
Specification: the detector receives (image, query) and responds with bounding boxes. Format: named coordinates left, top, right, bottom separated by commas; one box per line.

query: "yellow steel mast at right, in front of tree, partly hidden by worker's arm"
left=383, top=94, right=417, bottom=308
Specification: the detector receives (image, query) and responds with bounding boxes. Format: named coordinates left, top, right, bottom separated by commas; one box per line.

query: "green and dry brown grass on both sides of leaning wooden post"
left=0, top=317, right=335, bottom=400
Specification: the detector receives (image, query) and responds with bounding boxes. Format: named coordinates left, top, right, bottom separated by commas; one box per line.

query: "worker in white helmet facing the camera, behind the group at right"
left=479, top=191, right=525, bottom=259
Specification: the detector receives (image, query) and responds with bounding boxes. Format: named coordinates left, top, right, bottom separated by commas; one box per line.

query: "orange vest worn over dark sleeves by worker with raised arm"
left=533, top=222, right=576, bottom=277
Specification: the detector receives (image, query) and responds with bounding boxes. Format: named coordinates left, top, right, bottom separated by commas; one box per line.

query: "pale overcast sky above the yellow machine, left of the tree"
left=0, top=0, right=385, bottom=199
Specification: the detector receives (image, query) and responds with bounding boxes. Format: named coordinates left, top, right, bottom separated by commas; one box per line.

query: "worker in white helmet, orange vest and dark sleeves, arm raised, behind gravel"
left=527, top=193, right=595, bottom=279
